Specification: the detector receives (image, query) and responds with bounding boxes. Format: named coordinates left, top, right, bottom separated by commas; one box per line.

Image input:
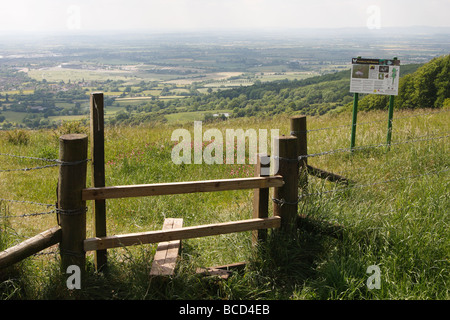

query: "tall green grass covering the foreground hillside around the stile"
left=0, top=110, right=450, bottom=299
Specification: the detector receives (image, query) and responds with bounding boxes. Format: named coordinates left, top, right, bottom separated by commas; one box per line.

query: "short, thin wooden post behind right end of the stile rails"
left=252, top=154, right=270, bottom=245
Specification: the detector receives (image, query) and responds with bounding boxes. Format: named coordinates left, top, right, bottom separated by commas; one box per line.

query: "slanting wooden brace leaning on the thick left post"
left=0, top=227, right=61, bottom=269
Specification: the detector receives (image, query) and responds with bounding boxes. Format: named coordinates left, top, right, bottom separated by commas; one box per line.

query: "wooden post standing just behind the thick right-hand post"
left=291, top=116, right=308, bottom=192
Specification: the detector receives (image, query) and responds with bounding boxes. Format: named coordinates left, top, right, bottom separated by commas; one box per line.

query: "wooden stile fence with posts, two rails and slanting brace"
left=0, top=93, right=330, bottom=276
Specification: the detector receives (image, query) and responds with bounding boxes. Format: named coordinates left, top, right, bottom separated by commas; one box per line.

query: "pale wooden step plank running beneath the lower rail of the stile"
left=150, top=218, right=183, bottom=276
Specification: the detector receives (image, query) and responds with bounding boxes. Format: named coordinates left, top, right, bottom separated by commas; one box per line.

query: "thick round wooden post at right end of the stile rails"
left=273, top=136, right=298, bottom=230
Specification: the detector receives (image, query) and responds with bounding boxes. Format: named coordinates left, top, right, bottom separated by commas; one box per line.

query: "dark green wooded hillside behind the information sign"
left=115, top=55, right=450, bottom=123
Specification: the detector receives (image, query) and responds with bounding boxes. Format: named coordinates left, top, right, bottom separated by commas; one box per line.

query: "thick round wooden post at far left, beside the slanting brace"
left=57, top=134, right=88, bottom=273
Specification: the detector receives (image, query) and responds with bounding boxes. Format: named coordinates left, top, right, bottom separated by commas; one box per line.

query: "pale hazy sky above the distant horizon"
left=0, top=0, right=450, bottom=32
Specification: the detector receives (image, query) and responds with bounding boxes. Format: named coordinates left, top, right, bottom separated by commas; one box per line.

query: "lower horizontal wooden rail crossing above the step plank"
left=84, top=216, right=281, bottom=251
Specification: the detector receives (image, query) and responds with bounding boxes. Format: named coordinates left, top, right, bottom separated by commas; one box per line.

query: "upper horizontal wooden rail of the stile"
left=82, top=176, right=284, bottom=200
